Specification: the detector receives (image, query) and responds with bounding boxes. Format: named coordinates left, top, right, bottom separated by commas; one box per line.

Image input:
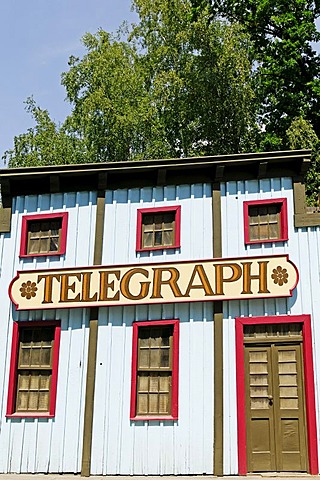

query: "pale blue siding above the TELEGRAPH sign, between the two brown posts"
left=103, top=184, right=212, bottom=265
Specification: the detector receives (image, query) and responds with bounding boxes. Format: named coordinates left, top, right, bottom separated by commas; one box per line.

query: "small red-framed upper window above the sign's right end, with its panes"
left=243, top=198, right=288, bottom=244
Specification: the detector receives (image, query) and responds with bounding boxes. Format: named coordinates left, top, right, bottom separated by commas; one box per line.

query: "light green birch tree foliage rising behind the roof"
left=5, top=0, right=254, bottom=166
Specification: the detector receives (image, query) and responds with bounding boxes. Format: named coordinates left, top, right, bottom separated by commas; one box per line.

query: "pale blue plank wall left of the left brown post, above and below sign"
left=0, top=192, right=96, bottom=473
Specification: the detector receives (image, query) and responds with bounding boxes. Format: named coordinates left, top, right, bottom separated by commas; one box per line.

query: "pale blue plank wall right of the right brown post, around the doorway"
left=221, top=178, right=320, bottom=475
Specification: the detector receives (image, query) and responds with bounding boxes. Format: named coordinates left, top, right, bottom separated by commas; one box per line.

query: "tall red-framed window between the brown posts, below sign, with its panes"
left=130, top=320, right=179, bottom=420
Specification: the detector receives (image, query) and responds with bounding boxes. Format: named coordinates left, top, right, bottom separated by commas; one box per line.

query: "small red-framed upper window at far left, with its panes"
left=20, top=212, right=68, bottom=257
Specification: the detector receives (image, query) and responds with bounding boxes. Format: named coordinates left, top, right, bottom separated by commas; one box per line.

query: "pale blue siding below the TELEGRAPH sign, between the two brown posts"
left=91, top=303, right=213, bottom=475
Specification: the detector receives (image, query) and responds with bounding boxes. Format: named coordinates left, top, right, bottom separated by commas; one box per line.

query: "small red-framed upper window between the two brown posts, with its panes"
left=136, top=206, right=181, bottom=252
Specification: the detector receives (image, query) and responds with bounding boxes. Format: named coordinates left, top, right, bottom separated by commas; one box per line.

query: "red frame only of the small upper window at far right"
left=243, top=198, right=289, bottom=245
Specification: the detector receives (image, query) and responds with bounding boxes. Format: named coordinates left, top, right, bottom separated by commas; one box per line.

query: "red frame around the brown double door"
left=235, top=315, right=319, bottom=475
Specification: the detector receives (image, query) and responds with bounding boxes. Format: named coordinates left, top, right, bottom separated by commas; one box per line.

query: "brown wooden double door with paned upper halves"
left=245, top=338, right=308, bottom=472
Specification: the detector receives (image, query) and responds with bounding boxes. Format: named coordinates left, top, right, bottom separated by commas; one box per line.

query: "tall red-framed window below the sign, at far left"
left=7, top=321, right=60, bottom=417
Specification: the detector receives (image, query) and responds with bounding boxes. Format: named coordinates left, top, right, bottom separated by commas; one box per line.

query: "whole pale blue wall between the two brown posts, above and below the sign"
left=91, top=184, right=213, bottom=475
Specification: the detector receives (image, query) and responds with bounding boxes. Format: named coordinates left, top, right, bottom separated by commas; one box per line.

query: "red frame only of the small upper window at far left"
left=19, top=212, right=68, bottom=258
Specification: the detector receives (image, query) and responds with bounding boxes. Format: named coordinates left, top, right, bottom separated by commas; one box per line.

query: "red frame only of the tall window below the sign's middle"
left=130, top=319, right=179, bottom=421
